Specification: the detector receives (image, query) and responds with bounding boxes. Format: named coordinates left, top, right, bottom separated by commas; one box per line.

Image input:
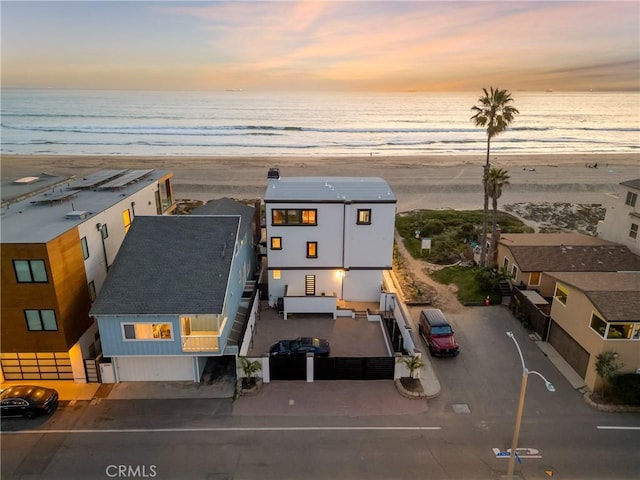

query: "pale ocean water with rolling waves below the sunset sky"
left=0, top=89, right=640, bottom=156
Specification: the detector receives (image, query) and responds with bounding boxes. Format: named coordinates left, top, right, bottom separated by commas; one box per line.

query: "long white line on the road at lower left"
left=0, top=427, right=442, bottom=435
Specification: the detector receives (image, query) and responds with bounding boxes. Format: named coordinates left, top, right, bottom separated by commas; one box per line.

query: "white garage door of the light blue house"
left=114, top=357, right=194, bottom=382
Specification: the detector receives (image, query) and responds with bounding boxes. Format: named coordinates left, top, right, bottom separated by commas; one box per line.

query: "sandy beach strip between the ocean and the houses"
left=0, top=154, right=640, bottom=211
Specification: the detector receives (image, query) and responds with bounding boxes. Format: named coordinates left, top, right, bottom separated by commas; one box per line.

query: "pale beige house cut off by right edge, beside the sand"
left=598, top=178, right=640, bottom=255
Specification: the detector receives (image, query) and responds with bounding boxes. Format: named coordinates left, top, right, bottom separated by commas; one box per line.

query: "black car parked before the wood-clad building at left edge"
left=0, top=385, right=58, bottom=418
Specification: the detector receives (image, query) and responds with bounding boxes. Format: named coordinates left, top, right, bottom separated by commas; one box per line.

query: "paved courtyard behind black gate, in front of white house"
left=248, top=302, right=389, bottom=357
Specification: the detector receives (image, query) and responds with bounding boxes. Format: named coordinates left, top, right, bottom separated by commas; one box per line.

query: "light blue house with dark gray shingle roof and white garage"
left=91, top=206, right=256, bottom=382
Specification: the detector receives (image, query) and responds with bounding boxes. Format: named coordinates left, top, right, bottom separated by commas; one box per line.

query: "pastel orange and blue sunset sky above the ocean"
left=1, top=0, right=640, bottom=91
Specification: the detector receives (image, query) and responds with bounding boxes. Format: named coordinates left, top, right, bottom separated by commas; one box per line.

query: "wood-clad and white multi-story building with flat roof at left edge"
left=0, top=170, right=175, bottom=383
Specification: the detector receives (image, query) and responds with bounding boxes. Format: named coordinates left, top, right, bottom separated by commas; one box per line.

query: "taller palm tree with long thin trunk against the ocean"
left=471, top=87, right=520, bottom=267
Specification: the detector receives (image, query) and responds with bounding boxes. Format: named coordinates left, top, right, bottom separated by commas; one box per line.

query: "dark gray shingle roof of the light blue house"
left=91, top=215, right=240, bottom=315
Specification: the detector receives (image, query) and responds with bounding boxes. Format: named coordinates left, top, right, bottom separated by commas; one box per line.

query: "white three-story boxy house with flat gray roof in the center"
left=264, top=172, right=396, bottom=318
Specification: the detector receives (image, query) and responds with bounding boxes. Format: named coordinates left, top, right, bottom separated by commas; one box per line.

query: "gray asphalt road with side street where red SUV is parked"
left=0, top=307, right=640, bottom=480
